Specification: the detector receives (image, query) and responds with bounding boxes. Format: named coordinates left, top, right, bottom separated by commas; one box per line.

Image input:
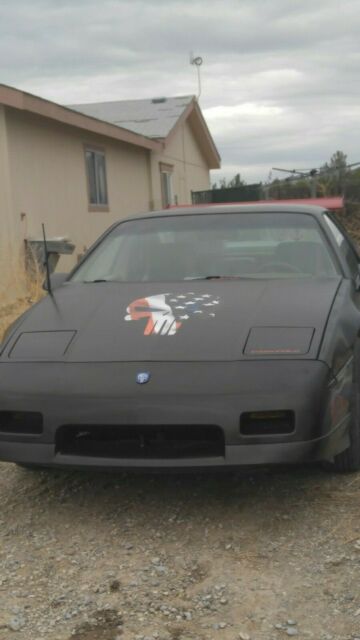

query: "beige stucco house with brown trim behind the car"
left=0, top=85, right=220, bottom=270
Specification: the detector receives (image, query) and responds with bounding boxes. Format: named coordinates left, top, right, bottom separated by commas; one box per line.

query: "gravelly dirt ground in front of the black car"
left=0, top=463, right=360, bottom=640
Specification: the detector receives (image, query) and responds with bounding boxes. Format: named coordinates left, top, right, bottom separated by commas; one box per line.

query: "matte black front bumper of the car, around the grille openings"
left=0, top=360, right=350, bottom=469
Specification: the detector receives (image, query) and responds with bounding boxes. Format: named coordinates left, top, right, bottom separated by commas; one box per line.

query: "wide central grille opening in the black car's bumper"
left=56, top=425, right=225, bottom=459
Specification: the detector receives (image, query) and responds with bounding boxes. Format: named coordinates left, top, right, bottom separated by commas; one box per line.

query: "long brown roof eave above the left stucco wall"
left=0, top=84, right=163, bottom=152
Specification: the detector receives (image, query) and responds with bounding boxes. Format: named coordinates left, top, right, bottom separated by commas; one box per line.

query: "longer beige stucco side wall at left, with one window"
left=7, top=109, right=151, bottom=270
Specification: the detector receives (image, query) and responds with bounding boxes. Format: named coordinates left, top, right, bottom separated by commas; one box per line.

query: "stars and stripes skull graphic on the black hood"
left=125, top=291, right=220, bottom=336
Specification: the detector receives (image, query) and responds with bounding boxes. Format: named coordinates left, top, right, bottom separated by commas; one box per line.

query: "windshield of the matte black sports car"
left=71, top=213, right=337, bottom=282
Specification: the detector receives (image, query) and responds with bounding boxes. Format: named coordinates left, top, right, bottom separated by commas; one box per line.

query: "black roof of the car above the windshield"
left=123, top=202, right=329, bottom=228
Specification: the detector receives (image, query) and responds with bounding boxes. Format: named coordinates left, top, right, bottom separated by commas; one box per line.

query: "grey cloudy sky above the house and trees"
left=0, top=0, right=360, bottom=183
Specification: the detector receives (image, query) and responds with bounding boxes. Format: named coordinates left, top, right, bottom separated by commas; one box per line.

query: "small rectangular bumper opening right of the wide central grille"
left=240, top=411, right=295, bottom=436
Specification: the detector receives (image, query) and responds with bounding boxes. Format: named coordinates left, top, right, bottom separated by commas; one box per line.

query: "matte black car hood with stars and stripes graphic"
left=2, top=277, right=341, bottom=362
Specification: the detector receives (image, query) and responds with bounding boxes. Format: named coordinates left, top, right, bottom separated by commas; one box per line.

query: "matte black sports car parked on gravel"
left=0, top=204, right=360, bottom=471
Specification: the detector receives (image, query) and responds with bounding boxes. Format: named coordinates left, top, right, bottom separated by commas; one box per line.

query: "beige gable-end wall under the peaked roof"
left=151, top=121, right=210, bottom=210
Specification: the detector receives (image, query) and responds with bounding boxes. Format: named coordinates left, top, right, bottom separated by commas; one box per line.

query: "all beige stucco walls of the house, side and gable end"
left=0, top=108, right=209, bottom=270
